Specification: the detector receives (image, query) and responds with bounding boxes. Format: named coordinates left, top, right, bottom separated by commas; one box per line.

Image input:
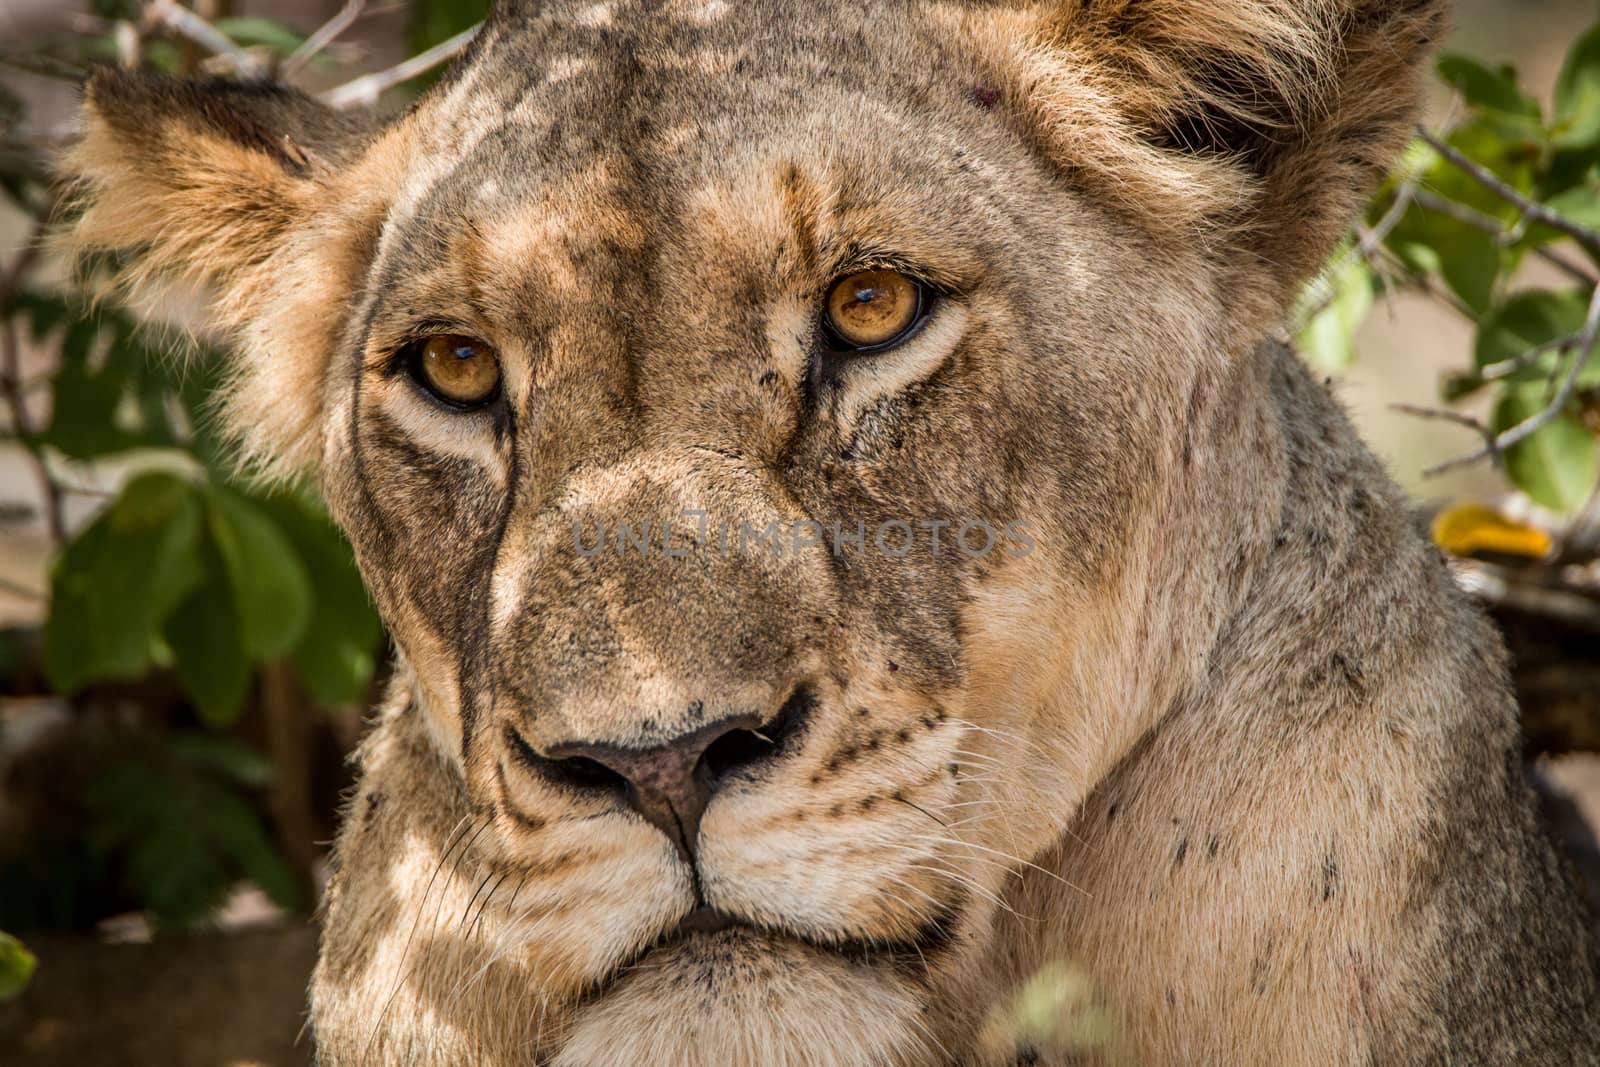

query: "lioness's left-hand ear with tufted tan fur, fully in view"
left=62, top=72, right=387, bottom=469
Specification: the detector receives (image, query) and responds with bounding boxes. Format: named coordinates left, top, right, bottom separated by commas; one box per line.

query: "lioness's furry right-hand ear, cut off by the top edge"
left=966, top=0, right=1445, bottom=342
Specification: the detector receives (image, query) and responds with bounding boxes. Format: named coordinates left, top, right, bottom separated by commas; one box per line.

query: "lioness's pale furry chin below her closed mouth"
left=552, top=928, right=928, bottom=1067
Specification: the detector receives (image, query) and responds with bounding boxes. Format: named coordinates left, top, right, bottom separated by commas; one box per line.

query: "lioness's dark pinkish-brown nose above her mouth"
left=549, top=715, right=776, bottom=862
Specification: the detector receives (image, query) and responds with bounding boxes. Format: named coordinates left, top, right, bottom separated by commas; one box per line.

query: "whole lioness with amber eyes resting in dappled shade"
left=56, top=0, right=1600, bottom=1067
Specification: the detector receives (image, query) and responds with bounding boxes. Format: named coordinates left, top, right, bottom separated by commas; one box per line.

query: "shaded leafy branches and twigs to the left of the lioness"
left=0, top=0, right=483, bottom=934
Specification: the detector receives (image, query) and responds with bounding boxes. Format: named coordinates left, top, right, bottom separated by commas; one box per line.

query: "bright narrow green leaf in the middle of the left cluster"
left=206, top=485, right=312, bottom=661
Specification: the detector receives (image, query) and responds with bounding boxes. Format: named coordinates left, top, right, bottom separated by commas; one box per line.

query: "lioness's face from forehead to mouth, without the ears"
left=323, top=10, right=1164, bottom=1043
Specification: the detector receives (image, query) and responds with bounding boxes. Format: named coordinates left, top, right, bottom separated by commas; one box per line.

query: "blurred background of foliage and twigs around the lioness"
left=0, top=0, right=1600, bottom=1065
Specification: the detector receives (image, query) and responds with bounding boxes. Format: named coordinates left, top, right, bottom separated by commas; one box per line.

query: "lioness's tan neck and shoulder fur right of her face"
left=965, top=341, right=1600, bottom=1065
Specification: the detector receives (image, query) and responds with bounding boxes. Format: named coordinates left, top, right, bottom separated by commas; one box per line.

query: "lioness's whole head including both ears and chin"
left=62, top=0, right=1437, bottom=1064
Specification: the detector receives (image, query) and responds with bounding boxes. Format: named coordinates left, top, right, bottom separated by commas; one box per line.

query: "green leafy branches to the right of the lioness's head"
left=1299, top=27, right=1600, bottom=524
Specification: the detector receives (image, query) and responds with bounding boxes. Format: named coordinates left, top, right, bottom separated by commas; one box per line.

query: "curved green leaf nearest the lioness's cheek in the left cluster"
left=261, top=494, right=382, bottom=704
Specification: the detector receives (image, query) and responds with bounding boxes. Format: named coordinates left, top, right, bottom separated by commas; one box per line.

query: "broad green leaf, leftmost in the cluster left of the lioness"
left=45, top=474, right=203, bottom=693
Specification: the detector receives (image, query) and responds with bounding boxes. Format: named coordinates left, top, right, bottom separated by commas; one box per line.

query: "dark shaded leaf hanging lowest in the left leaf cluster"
left=163, top=544, right=251, bottom=726
